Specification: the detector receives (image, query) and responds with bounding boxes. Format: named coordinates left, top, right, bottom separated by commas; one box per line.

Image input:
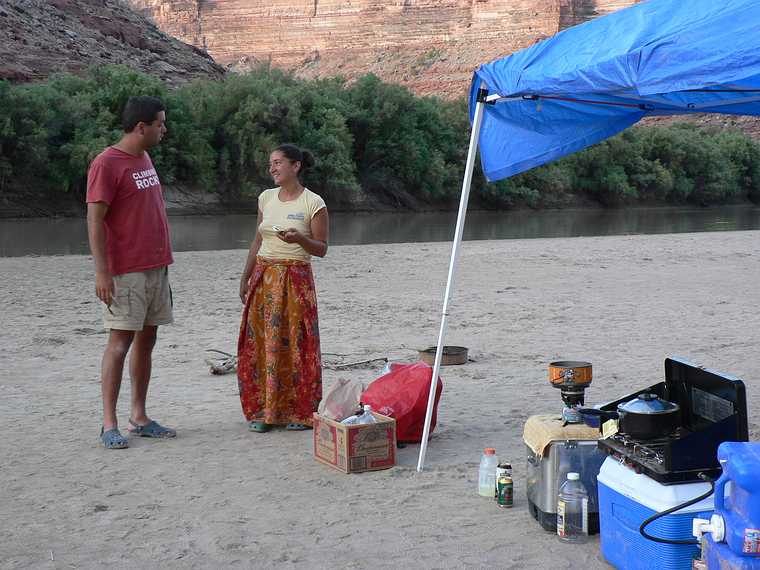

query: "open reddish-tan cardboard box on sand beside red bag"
left=314, top=412, right=396, bottom=473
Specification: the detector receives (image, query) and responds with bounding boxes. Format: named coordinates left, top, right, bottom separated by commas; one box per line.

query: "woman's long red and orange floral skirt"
left=238, top=257, right=322, bottom=425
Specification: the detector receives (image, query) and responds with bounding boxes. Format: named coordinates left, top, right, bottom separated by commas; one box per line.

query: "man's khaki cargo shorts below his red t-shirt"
left=103, top=267, right=174, bottom=331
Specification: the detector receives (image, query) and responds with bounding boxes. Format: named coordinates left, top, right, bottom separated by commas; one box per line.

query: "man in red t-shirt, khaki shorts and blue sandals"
left=87, top=97, right=177, bottom=449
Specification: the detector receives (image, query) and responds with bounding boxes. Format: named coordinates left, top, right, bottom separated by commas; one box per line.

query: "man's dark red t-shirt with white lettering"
left=87, top=147, right=174, bottom=275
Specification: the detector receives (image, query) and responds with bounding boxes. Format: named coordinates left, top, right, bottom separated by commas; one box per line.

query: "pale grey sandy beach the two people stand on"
left=0, top=232, right=760, bottom=570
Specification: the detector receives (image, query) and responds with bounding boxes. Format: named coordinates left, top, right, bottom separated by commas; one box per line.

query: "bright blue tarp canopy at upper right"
left=470, top=0, right=760, bottom=180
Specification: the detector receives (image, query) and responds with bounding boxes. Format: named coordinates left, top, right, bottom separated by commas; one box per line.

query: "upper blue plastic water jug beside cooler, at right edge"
left=715, top=441, right=760, bottom=558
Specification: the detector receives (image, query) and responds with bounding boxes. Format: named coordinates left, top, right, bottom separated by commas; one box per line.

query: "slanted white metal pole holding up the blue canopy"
left=417, top=85, right=488, bottom=472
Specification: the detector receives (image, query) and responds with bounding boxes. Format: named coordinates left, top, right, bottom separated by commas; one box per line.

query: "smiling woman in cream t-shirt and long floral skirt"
left=238, top=144, right=329, bottom=432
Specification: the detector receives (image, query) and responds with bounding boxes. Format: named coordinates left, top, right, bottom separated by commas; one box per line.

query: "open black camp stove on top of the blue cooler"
left=599, top=358, right=749, bottom=485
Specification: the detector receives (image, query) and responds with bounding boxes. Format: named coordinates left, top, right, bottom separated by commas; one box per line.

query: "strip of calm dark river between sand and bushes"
left=0, top=205, right=760, bottom=257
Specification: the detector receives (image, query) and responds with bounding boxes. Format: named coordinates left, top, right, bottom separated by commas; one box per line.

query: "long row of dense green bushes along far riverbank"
left=0, top=66, right=760, bottom=208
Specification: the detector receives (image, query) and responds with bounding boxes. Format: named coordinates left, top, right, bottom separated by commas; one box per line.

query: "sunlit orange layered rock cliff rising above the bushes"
left=126, top=0, right=638, bottom=97
